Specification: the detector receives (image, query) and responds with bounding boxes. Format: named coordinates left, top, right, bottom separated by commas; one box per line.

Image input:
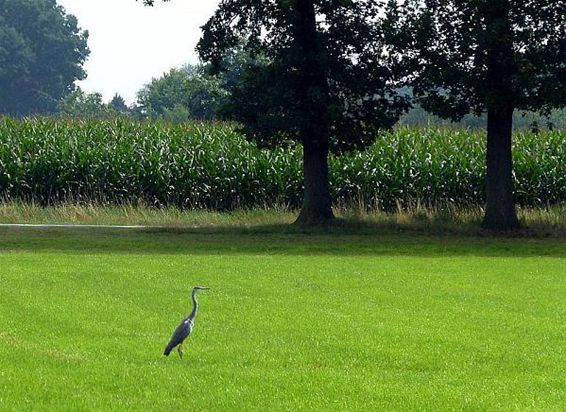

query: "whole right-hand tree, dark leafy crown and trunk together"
left=387, top=0, right=566, bottom=230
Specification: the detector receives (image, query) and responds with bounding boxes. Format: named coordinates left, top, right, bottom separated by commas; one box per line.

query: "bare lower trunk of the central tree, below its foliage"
left=296, top=141, right=334, bottom=226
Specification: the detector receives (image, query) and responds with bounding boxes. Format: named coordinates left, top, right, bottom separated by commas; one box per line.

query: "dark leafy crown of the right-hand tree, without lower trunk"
left=387, top=0, right=566, bottom=119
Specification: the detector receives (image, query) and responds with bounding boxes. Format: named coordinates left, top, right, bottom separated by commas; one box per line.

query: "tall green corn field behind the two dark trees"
left=0, top=118, right=566, bottom=210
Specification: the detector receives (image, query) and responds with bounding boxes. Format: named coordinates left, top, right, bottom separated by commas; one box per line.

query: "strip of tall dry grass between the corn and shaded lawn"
left=0, top=202, right=566, bottom=237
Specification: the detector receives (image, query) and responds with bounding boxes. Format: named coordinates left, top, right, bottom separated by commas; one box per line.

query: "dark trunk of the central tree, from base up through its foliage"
left=289, top=0, right=334, bottom=226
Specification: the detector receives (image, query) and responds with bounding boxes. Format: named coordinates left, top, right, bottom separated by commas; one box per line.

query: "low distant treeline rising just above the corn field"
left=56, top=62, right=566, bottom=133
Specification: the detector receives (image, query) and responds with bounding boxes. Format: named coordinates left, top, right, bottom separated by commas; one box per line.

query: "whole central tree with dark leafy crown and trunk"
left=198, top=0, right=407, bottom=225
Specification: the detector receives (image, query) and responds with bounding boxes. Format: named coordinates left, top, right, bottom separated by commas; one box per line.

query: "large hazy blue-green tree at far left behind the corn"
left=0, top=0, right=89, bottom=116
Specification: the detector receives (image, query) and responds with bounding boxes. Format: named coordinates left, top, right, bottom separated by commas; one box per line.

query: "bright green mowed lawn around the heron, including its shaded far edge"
left=0, top=228, right=566, bottom=411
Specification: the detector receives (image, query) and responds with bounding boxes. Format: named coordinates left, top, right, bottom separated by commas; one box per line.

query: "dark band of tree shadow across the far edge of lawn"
left=0, top=222, right=566, bottom=258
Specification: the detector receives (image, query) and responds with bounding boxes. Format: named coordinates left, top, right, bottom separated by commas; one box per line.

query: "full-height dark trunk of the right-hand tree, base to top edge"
left=483, top=0, right=519, bottom=230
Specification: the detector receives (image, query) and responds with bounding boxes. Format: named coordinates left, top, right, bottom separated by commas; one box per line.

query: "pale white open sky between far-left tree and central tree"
left=57, top=0, right=220, bottom=104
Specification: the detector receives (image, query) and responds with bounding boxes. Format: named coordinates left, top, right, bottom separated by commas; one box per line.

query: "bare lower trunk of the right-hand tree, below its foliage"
left=482, top=108, right=519, bottom=230
